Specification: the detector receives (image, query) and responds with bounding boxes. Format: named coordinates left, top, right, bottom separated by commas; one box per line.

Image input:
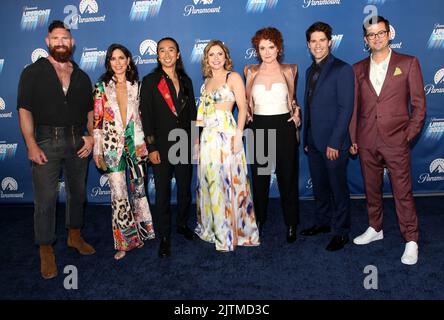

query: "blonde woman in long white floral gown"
left=196, top=40, right=259, bottom=251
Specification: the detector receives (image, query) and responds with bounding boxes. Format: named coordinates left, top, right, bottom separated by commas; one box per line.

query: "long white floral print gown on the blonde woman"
left=195, top=84, right=259, bottom=251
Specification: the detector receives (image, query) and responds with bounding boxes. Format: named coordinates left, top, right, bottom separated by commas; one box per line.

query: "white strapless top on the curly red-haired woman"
left=251, top=82, right=289, bottom=116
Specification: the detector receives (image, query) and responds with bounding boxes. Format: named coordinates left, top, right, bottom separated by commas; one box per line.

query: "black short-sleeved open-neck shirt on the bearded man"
left=17, top=58, right=93, bottom=127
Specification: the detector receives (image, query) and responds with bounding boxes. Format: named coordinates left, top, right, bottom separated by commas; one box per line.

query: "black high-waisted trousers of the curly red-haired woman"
left=251, top=113, right=299, bottom=226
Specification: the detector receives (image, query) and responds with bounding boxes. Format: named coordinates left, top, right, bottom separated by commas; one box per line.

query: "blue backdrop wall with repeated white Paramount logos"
left=0, top=0, right=444, bottom=203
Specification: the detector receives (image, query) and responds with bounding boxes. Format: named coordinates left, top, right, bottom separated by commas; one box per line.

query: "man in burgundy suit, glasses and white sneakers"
left=350, top=16, right=426, bottom=265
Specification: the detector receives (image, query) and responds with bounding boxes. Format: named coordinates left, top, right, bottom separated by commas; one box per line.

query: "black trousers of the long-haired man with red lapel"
left=153, top=159, right=193, bottom=238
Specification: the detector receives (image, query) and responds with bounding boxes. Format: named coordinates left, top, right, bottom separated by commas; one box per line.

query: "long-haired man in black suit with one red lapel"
left=140, top=38, right=196, bottom=257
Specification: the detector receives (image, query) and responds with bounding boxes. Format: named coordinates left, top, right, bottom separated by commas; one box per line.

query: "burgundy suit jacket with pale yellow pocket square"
left=350, top=50, right=426, bottom=148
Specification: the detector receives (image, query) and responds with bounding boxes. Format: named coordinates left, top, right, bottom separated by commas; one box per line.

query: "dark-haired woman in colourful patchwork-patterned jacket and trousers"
left=93, top=44, right=154, bottom=260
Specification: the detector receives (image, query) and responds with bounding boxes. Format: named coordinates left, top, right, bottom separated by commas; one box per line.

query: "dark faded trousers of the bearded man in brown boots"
left=32, top=126, right=88, bottom=245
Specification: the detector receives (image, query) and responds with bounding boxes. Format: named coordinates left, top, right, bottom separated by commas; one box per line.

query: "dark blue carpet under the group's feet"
left=0, top=197, right=444, bottom=300
